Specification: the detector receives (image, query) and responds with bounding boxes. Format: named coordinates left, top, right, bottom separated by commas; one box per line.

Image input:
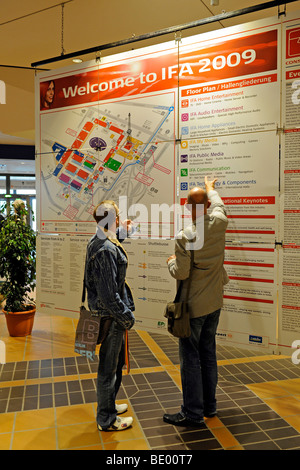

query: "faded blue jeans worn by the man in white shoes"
left=97, top=321, right=125, bottom=429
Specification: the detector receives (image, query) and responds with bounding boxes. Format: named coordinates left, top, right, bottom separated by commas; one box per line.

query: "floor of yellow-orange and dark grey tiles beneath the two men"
left=0, top=314, right=300, bottom=451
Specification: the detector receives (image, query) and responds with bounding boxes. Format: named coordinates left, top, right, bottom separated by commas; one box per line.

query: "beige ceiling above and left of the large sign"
left=0, top=0, right=300, bottom=173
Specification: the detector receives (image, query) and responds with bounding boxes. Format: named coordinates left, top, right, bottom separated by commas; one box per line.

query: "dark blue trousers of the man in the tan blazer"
left=179, top=309, right=220, bottom=421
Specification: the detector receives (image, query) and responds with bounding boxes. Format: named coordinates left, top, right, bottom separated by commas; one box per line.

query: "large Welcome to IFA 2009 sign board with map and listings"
left=36, top=10, right=299, bottom=350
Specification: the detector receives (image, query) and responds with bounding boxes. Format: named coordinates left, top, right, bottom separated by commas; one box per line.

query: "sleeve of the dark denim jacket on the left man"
left=94, top=250, right=134, bottom=329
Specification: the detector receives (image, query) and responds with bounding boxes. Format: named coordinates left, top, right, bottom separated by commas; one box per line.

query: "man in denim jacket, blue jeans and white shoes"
left=85, top=201, right=135, bottom=431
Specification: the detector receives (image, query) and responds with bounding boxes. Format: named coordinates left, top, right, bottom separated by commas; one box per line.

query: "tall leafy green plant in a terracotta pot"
left=0, top=199, right=36, bottom=336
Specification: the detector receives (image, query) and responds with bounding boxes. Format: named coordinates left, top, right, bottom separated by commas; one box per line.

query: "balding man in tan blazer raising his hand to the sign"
left=164, top=177, right=228, bottom=426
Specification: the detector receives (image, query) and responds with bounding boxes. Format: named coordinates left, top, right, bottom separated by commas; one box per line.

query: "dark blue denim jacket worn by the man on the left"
left=85, top=229, right=135, bottom=329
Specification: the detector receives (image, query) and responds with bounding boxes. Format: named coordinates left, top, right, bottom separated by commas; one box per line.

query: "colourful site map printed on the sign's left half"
left=38, top=93, right=175, bottom=233
